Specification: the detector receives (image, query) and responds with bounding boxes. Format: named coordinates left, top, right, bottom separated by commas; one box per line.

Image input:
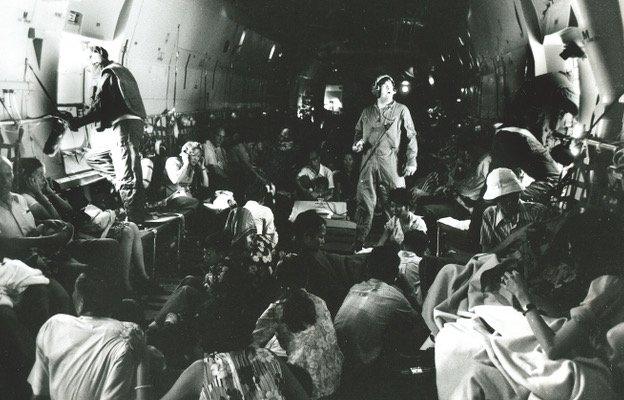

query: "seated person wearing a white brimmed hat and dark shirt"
left=481, top=168, right=547, bottom=252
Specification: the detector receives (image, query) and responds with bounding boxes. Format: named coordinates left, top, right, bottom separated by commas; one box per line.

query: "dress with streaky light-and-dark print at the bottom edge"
left=199, top=347, right=285, bottom=400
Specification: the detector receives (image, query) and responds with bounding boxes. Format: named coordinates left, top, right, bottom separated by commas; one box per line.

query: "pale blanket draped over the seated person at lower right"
left=435, top=306, right=617, bottom=400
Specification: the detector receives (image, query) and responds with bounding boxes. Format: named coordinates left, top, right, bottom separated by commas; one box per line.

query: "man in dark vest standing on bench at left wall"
left=68, top=46, right=146, bottom=223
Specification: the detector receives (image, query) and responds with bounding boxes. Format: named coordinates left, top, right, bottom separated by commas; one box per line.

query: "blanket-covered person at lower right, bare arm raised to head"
left=436, top=266, right=624, bottom=400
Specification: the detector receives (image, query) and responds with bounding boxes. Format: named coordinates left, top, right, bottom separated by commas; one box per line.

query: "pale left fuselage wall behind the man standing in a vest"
left=0, top=0, right=288, bottom=177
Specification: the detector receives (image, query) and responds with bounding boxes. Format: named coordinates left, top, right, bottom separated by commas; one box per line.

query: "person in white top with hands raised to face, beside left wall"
left=165, top=142, right=209, bottom=210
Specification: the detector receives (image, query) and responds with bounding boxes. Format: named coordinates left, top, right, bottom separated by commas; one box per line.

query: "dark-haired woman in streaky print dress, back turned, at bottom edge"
left=161, top=268, right=309, bottom=400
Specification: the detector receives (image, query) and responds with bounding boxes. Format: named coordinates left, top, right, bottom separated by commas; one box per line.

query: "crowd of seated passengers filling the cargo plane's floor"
left=0, top=103, right=624, bottom=399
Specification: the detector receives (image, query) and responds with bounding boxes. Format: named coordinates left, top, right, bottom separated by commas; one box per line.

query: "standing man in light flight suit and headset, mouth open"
left=353, top=75, right=418, bottom=250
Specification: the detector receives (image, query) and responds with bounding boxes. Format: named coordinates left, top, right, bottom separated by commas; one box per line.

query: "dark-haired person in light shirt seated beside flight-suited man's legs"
left=377, top=188, right=427, bottom=246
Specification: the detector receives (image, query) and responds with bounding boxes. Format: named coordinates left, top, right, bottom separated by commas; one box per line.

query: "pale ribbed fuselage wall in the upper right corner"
left=468, top=0, right=624, bottom=140
